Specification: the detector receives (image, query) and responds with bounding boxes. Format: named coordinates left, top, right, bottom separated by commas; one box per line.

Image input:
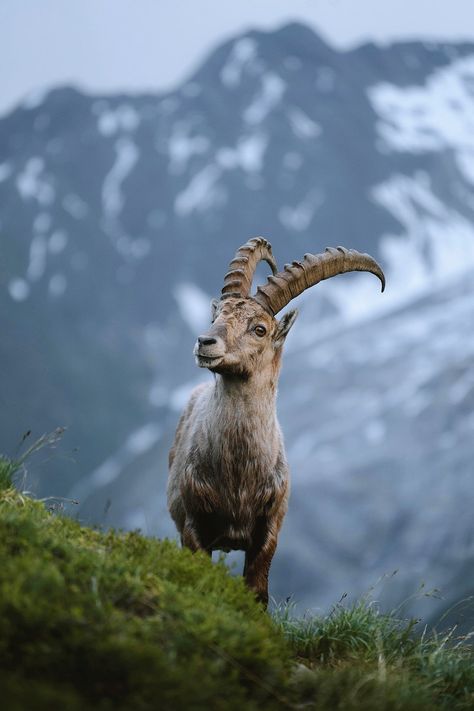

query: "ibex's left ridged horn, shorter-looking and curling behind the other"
left=221, top=237, right=277, bottom=299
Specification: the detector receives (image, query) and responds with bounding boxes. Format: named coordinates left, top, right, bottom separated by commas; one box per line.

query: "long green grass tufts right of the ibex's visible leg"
left=274, top=599, right=474, bottom=711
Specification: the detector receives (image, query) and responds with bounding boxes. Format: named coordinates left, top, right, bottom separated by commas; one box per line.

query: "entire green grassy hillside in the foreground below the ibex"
left=0, top=459, right=474, bottom=711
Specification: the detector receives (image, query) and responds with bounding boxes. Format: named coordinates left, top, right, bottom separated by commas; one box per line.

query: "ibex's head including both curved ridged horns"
left=194, top=237, right=385, bottom=376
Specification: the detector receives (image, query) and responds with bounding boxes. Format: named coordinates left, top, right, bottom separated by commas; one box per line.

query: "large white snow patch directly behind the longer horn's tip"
left=328, top=172, right=474, bottom=321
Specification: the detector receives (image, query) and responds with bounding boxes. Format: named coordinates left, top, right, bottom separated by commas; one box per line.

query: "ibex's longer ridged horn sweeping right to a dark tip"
left=253, top=247, right=385, bottom=316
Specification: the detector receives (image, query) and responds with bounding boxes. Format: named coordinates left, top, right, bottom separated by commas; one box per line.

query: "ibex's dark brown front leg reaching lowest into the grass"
left=244, top=520, right=277, bottom=607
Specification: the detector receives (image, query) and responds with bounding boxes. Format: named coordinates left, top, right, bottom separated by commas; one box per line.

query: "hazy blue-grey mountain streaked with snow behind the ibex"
left=0, top=24, right=474, bottom=609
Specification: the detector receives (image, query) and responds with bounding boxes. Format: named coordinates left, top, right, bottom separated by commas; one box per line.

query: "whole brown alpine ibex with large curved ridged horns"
left=168, top=237, right=385, bottom=605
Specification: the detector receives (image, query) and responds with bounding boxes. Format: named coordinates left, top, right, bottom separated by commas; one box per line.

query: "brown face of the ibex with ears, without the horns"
left=194, top=297, right=297, bottom=377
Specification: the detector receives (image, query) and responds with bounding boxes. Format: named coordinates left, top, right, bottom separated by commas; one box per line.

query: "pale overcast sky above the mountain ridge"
left=0, top=0, right=474, bottom=113
